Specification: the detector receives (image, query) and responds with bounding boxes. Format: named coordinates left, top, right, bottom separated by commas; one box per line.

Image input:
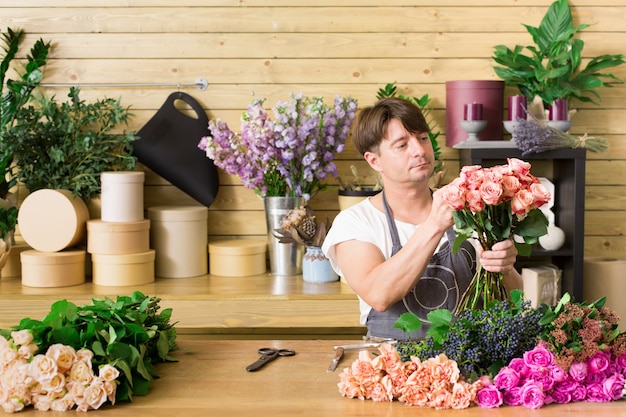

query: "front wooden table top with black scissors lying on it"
left=13, top=337, right=626, bottom=417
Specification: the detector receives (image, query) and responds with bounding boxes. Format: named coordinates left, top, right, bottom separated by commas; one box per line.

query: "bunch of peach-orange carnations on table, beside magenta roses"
left=337, top=344, right=483, bottom=410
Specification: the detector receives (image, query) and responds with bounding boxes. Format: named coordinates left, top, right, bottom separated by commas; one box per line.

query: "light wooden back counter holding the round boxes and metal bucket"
left=0, top=273, right=365, bottom=339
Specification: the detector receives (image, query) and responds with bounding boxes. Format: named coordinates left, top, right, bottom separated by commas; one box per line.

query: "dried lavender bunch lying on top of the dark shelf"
left=513, top=119, right=608, bottom=156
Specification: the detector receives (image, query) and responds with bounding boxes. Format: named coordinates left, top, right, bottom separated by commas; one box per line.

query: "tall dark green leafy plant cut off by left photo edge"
left=0, top=28, right=50, bottom=268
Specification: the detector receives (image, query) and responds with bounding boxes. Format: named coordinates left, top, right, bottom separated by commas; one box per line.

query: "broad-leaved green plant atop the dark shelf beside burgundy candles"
left=493, top=0, right=624, bottom=108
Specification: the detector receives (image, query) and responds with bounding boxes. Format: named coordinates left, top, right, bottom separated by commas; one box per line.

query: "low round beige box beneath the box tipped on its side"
left=20, top=250, right=85, bottom=288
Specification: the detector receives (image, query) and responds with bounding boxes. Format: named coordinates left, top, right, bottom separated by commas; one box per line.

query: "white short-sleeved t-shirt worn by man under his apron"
left=322, top=197, right=447, bottom=325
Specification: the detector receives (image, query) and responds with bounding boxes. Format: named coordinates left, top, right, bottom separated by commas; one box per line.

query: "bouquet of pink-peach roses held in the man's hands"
left=436, top=158, right=550, bottom=314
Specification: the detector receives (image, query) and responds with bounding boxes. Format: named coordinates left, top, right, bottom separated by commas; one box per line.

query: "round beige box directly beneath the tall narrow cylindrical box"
left=87, top=219, right=150, bottom=255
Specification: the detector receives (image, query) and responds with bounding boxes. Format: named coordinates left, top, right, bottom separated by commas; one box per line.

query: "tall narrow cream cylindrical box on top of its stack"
left=100, top=171, right=145, bottom=222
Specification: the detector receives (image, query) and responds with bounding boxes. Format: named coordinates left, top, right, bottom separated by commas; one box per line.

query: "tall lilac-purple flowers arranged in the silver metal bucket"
left=198, top=93, right=357, bottom=200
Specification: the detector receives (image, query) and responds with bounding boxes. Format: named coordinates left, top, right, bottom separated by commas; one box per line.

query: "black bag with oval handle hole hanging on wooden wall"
left=133, top=91, right=219, bottom=207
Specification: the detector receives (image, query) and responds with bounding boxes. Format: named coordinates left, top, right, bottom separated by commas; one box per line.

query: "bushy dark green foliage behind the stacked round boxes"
left=6, top=87, right=137, bottom=201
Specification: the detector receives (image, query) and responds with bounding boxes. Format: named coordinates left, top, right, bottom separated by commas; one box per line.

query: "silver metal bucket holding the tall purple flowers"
left=263, top=197, right=304, bottom=275
